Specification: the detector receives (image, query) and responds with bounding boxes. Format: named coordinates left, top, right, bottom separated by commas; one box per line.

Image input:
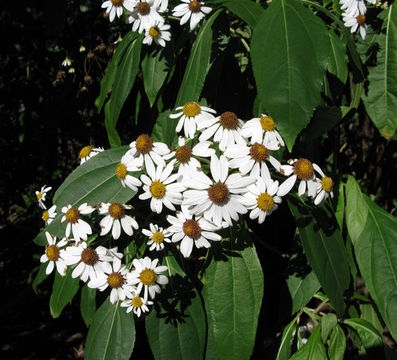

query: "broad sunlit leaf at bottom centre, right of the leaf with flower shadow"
left=203, top=240, right=263, bottom=359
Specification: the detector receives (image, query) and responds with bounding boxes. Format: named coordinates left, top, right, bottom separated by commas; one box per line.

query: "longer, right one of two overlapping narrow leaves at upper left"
left=105, top=35, right=143, bottom=147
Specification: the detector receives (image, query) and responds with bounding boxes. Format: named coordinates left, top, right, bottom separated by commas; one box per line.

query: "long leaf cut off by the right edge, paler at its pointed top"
left=346, top=177, right=397, bottom=339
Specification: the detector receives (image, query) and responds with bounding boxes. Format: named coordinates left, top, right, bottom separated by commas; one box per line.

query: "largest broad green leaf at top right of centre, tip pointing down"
left=251, top=0, right=330, bottom=150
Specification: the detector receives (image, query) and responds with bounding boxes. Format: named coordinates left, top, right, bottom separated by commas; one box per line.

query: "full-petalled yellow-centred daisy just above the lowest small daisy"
left=127, top=256, right=168, bottom=300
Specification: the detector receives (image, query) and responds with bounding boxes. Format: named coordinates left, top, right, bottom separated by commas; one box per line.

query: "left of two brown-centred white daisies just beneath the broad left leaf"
left=61, top=203, right=95, bottom=243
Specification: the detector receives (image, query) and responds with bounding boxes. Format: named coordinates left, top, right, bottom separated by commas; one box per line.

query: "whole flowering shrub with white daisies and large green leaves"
left=35, top=0, right=397, bottom=359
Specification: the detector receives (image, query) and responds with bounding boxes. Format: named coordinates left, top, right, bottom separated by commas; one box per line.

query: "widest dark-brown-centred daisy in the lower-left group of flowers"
left=63, top=242, right=113, bottom=282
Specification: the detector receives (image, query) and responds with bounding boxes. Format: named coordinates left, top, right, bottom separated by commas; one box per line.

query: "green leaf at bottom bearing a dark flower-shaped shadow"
left=146, top=256, right=206, bottom=360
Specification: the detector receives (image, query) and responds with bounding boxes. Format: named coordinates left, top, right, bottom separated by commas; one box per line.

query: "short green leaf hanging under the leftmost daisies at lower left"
left=50, top=267, right=80, bottom=318
